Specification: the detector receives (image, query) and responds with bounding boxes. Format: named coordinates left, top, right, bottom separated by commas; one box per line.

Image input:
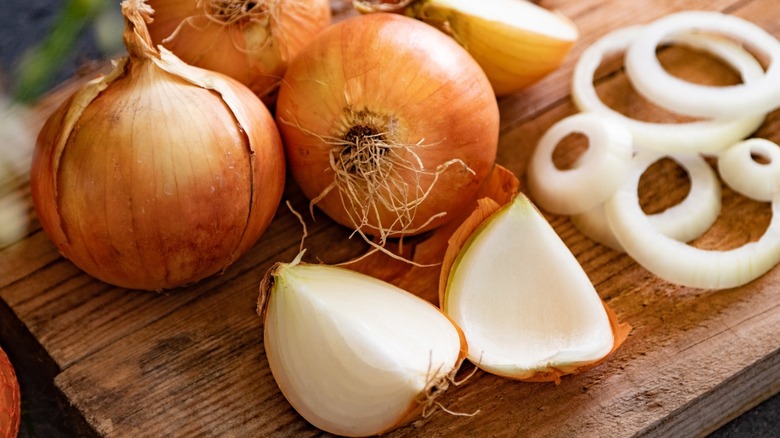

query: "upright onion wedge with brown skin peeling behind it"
left=440, top=194, right=630, bottom=382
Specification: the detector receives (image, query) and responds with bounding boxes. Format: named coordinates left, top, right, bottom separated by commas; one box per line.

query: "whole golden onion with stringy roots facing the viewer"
left=276, top=14, right=499, bottom=245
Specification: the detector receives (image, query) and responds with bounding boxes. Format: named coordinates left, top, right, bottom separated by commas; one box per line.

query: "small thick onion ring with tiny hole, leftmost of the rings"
left=528, top=113, right=632, bottom=214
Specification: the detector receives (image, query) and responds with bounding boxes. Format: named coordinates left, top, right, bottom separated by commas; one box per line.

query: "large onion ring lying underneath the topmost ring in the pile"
left=572, top=26, right=764, bottom=153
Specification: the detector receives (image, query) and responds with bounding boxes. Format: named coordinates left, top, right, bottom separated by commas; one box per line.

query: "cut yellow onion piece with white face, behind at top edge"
left=353, top=0, right=578, bottom=96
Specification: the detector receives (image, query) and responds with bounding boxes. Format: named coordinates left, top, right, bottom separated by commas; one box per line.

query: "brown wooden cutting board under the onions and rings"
left=0, top=0, right=780, bottom=437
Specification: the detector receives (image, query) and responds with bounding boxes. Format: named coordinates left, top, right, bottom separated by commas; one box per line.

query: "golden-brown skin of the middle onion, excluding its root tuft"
left=276, top=13, right=499, bottom=234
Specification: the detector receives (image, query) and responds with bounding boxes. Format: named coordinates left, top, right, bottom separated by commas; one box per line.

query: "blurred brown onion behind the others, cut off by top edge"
left=148, top=0, right=331, bottom=103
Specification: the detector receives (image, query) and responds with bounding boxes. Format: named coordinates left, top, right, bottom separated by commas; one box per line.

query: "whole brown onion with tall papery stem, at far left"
left=31, top=0, right=285, bottom=290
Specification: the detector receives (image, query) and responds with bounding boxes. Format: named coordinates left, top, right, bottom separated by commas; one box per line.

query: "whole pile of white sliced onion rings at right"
left=528, top=11, right=780, bottom=289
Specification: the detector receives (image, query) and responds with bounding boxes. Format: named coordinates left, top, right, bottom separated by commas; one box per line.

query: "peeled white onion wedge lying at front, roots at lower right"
left=264, top=262, right=462, bottom=436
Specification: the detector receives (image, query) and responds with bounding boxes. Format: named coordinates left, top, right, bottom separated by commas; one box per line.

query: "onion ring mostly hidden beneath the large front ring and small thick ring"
left=571, top=151, right=721, bottom=251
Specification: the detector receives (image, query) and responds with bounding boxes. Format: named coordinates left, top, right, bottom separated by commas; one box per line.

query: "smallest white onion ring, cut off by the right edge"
left=718, top=138, right=780, bottom=202
